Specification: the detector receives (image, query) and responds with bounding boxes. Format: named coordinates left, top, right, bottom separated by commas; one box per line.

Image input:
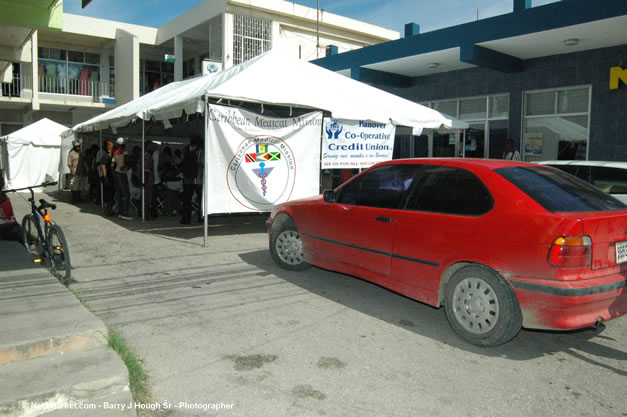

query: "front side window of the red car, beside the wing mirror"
left=337, top=164, right=421, bottom=209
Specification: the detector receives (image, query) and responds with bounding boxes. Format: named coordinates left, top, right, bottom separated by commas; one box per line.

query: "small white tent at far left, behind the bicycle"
left=0, top=119, right=68, bottom=188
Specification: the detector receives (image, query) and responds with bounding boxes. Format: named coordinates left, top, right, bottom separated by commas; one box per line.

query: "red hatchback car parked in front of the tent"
left=266, top=159, right=627, bottom=346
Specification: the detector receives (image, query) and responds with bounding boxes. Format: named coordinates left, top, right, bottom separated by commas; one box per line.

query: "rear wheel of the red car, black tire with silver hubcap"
left=444, top=265, right=522, bottom=347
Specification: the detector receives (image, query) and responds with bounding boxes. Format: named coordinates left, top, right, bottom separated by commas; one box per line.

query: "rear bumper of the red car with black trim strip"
left=509, top=274, right=627, bottom=330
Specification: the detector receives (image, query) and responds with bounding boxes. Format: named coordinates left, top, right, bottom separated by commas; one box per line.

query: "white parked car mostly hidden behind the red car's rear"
left=538, top=161, right=627, bottom=204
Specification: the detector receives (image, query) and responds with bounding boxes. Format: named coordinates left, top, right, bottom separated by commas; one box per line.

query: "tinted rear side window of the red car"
left=406, top=166, right=494, bottom=216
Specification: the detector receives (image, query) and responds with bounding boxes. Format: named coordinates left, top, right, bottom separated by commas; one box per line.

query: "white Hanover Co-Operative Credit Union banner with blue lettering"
left=322, top=117, right=396, bottom=169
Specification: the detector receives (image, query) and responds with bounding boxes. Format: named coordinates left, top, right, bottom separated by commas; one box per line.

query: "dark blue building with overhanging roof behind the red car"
left=314, top=0, right=627, bottom=161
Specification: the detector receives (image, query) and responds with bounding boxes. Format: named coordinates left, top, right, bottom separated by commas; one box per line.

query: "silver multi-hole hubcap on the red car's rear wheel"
left=453, top=278, right=499, bottom=334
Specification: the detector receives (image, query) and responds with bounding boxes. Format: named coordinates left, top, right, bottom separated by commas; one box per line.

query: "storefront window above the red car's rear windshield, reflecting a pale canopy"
left=522, top=87, right=590, bottom=161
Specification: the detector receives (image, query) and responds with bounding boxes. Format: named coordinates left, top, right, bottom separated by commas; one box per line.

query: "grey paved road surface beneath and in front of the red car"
left=13, top=192, right=627, bottom=417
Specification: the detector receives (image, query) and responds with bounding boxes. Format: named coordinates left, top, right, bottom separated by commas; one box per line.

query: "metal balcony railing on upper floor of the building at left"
left=0, top=74, right=114, bottom=101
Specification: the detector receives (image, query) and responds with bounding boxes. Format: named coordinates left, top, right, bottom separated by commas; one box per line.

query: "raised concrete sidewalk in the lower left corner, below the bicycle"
left=0, top=241, right=136, bottom=417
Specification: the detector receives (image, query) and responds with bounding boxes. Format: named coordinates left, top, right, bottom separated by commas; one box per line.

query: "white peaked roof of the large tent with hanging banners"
left=74, top=51, right=468, bottom=135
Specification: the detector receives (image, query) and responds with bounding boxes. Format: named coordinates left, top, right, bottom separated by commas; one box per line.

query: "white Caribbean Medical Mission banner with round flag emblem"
left=205, top=105, right=322, bottom=214
